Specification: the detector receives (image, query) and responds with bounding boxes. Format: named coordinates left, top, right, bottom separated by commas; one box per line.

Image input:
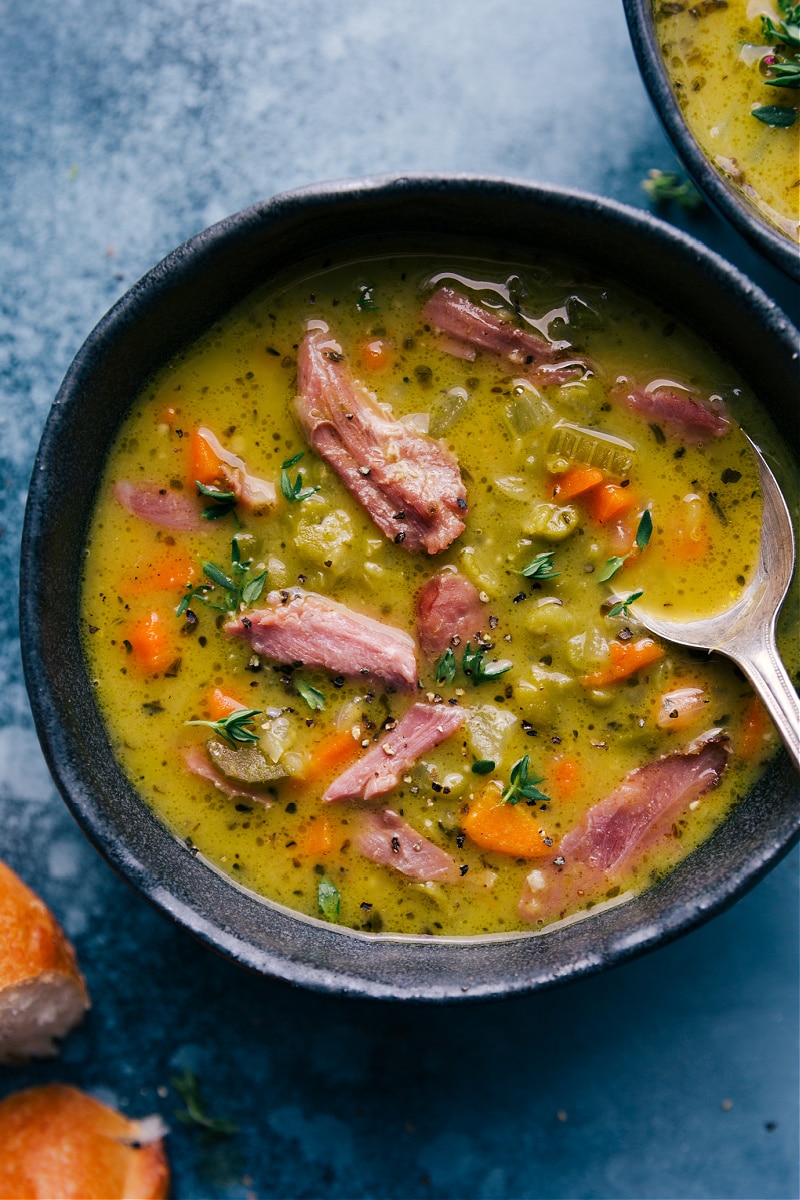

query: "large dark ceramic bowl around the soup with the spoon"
left=22, top=176, right=800, bottom=1000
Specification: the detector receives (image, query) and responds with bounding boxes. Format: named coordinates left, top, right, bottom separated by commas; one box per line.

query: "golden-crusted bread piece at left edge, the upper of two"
left=0, top=863, right=89, bottom=1063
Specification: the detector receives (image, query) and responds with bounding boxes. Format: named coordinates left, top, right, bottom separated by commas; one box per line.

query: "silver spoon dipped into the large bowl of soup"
left=631, top=434, right=800, bottom=770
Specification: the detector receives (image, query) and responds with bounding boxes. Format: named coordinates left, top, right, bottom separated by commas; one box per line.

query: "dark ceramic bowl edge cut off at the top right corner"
left=622, top=0, right=800, bottom=280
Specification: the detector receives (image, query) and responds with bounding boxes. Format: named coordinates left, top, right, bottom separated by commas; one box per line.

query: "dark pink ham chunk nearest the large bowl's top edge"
left=422, top=286, right=585, bottom=384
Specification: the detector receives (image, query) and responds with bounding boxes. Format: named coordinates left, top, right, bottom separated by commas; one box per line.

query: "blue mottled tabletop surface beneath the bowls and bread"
left=0, top=0, right=799, bottom=1200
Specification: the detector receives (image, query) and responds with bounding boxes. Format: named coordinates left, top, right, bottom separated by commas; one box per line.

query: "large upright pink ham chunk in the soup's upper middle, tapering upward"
left=296, top=322, right=467, bottom=554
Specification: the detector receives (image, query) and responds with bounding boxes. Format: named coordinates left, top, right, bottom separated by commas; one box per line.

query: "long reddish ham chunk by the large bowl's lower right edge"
left=518, top=731, right=730, bottom=920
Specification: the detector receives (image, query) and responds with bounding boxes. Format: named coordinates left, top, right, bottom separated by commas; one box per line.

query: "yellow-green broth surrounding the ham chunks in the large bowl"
left=82, top=256, right=796, bottom=936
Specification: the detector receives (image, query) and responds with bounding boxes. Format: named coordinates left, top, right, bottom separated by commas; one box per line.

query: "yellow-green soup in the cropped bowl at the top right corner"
left=654, top=0, right=800, bottom=242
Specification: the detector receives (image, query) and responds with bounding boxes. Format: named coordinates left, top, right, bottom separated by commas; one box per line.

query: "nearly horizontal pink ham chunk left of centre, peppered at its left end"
left=225, top=588, right=417, bottom=690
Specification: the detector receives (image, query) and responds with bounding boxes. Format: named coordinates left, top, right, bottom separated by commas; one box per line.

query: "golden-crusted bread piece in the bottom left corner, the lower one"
left=0, top=1084, right=169, bottom=1200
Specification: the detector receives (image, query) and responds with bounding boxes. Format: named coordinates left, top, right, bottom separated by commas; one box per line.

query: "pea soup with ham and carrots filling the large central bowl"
left=82, top=256, right=791, bottom=936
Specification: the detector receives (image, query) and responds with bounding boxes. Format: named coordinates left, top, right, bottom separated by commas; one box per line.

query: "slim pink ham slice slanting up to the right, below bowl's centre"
left=323, top=704, right=467, bottom=800
